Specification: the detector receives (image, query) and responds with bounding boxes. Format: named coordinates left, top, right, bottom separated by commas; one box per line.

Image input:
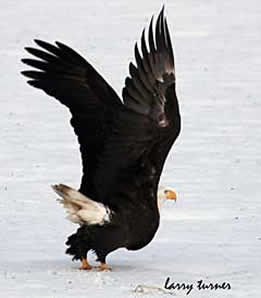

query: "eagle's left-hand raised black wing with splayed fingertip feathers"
left=22, top=40, right=122, bottom=197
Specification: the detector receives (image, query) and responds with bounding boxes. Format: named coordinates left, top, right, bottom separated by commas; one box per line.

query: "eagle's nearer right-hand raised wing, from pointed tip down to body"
left=92, top=9, right=180, bottom=200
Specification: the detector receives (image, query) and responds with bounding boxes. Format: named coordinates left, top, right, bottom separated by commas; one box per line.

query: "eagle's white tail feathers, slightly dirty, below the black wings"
left=52, top=184, right=111, bottom=225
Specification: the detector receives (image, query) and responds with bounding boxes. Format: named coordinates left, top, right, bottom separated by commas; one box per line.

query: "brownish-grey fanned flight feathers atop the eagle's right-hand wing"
left=122, top=8, right=177, bottom=127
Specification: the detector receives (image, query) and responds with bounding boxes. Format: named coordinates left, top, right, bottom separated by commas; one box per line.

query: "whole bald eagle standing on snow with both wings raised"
left=22, top=7, right=181, bottom=270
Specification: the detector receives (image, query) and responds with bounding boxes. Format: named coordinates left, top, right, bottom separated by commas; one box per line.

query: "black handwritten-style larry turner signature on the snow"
left=164, top=277, right=231, bottom=295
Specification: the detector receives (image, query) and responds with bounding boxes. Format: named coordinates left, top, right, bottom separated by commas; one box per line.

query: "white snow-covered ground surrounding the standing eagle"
left=0, top=0, right=261, bottom=298
